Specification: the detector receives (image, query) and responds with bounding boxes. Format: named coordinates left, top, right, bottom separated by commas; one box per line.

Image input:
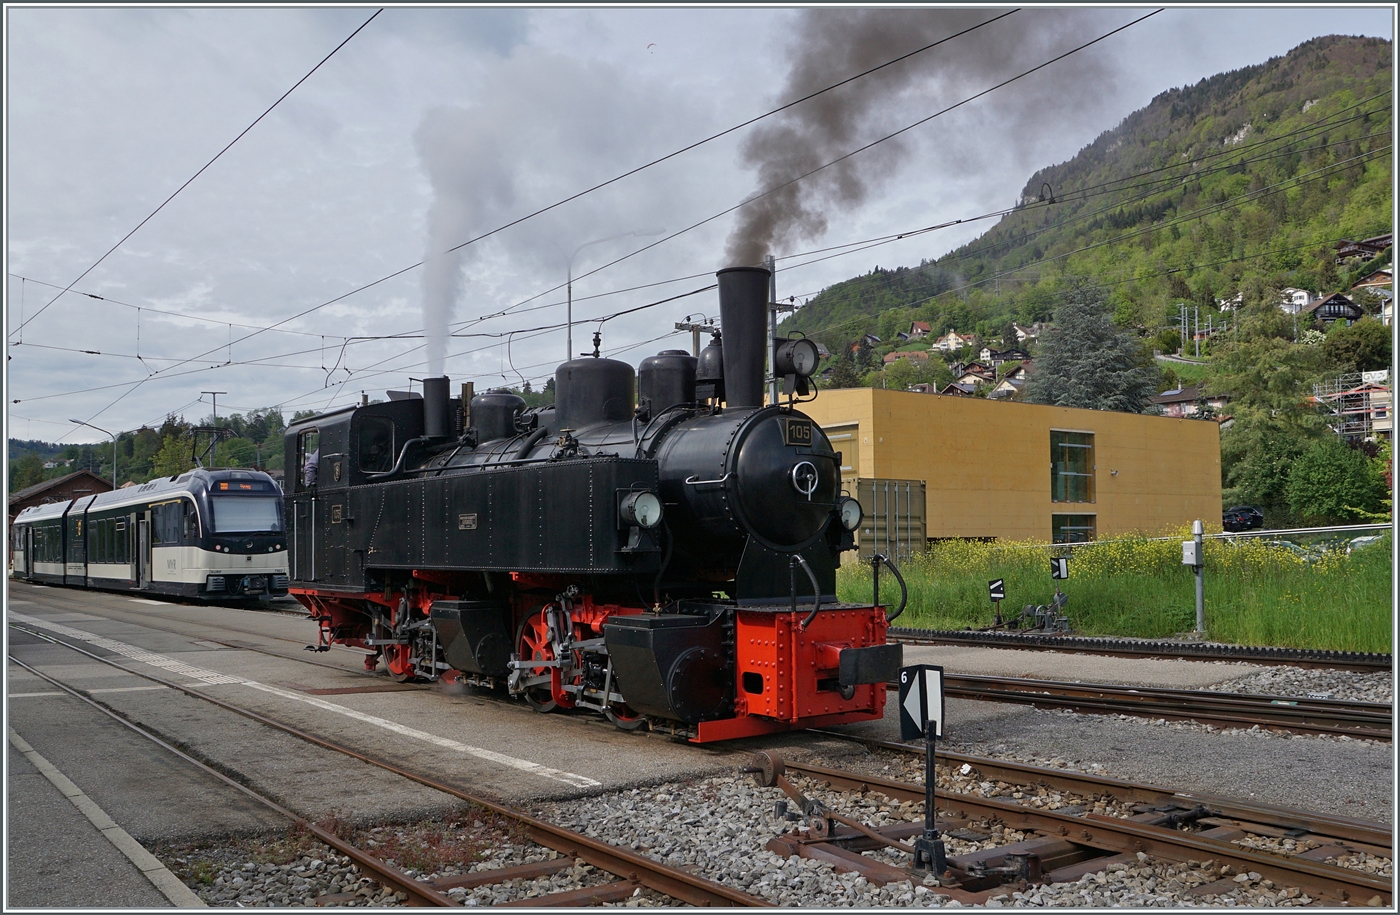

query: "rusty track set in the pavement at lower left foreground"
left=10, top=623, right=767, bottom=908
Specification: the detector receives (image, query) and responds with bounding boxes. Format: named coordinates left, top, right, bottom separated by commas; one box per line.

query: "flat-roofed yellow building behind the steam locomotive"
left=802, top=388, right=1221, bottom=541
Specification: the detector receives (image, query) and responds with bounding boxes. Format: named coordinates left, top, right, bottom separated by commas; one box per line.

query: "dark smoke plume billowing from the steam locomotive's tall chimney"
left=724, top=8, right=1121, bottom=264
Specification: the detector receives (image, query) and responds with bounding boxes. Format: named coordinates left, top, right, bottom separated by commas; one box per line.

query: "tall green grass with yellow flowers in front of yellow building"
left=837, top=532, right=1393, bottom=652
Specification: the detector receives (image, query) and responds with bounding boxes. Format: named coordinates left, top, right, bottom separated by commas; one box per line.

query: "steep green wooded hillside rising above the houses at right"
left=781, top=36, right=1392, bottom=353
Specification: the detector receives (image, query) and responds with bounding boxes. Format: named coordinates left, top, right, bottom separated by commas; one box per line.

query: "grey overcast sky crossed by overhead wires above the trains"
left=4, top=6, right=1393, bottom=442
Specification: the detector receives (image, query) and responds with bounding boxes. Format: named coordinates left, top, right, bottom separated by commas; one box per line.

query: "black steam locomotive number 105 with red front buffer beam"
left=286, top=267, right=900, bottom=742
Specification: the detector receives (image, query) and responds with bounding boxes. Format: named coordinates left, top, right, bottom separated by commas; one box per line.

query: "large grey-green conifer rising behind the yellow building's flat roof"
left=1026, top=277, right=1158, bottom=413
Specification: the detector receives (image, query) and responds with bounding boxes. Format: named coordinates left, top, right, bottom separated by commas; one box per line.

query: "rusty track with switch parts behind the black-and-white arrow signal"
left=750, top=755, right=1393, bottom=907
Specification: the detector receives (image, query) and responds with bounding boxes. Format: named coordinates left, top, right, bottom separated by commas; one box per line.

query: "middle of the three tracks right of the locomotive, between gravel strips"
left=924, top=673, right=1392, bottom=740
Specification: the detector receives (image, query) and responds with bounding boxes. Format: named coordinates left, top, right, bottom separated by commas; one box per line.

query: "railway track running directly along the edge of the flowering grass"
left=889, top=627, right=1393, bottom=673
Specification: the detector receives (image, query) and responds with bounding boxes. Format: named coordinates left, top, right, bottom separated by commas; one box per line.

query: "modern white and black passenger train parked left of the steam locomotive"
left=11, top=470, right=288, bottom=599
